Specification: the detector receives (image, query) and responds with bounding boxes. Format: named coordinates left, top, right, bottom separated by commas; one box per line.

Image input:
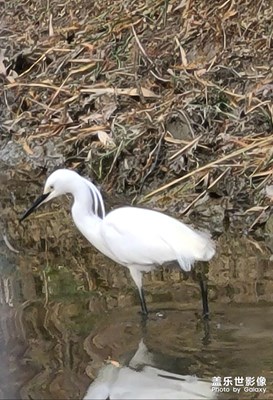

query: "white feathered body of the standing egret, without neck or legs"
left=100, top=207, right=215, bottom=271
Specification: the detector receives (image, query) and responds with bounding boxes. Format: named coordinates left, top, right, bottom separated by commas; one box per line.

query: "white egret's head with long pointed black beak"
left=20, top=169, right=80, bottom=222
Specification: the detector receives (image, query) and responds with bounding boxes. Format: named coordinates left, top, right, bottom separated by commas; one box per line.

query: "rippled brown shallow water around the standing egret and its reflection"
left=0, top=167, right=273, bottom=399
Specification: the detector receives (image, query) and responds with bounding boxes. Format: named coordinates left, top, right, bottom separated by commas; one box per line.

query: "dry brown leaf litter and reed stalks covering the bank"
left=0, top=0, right=273, bottom=233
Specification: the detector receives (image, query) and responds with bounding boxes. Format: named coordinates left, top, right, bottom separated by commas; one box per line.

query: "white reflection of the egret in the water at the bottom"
left=83, top=340, right=216, bottom=400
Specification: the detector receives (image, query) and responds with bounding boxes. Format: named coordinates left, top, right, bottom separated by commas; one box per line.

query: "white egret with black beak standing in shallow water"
left=20, top=169, right=215, bottom=316
